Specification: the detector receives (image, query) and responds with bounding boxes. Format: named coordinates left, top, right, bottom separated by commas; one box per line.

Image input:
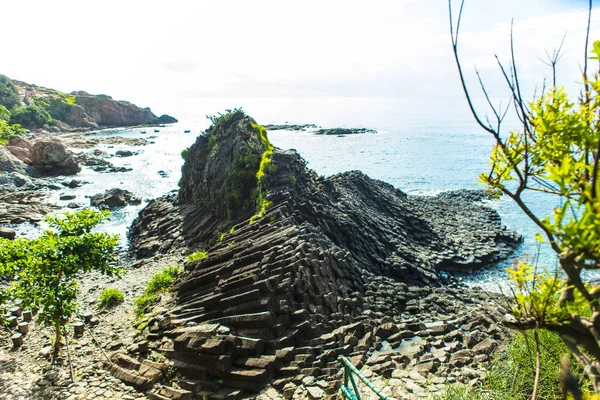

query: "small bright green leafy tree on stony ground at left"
left=0, top=209, right=122, bottom=351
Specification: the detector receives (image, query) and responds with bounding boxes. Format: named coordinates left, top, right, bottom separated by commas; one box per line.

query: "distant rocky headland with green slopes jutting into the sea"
left=12, top=80, right=177, bottom=131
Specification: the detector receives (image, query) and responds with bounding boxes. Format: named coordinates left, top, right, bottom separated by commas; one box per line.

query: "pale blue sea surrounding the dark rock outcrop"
left=11, top=96, right=559, bottom=290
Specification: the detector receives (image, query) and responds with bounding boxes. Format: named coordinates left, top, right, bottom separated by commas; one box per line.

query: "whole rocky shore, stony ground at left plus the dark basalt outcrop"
left=0, top=112, right=521, bottom=400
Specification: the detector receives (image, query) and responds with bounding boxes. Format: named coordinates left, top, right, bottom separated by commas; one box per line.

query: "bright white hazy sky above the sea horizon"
left=0, top=0, right=600, bottom=114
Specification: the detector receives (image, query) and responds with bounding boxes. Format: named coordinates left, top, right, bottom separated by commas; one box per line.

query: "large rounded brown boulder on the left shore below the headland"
left=30, top=138, right=81, bottom=175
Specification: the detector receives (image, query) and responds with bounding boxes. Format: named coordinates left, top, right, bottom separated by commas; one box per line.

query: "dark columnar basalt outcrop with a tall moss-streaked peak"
left=130, top=112, right=519, bottom=398
